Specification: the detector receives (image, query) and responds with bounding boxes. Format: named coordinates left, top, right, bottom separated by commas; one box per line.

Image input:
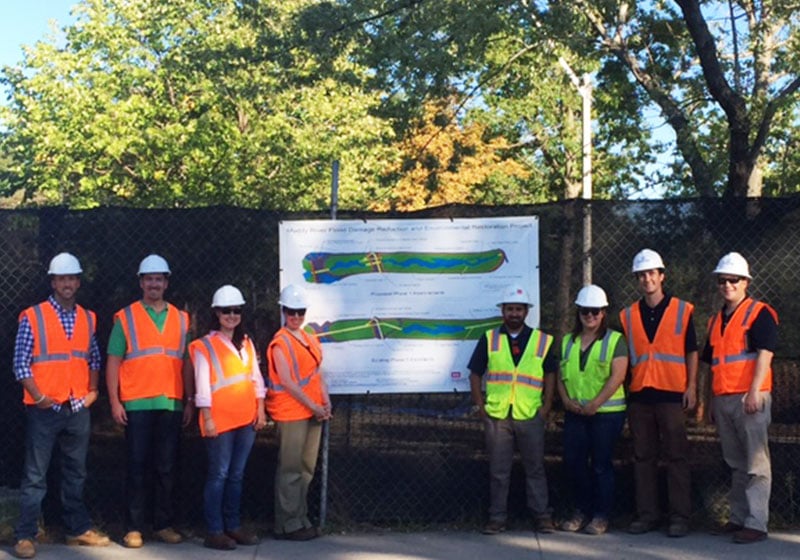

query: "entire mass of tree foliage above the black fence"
left=0, top=0, right=800, bottom=210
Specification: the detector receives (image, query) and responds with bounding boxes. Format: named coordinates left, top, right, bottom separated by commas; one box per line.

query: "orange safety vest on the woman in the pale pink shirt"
left=189, top=334, right=258, bottom=437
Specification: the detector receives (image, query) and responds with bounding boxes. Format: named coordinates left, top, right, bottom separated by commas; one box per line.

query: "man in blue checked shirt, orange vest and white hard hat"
left=14, top=253, right=110, bottom=558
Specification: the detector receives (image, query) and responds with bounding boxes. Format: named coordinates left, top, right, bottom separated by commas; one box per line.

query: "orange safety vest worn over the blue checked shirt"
left=19, top=301, right=96, bottom=404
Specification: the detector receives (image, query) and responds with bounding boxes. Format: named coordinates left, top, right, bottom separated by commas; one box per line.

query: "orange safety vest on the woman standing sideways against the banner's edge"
left=266, top=327, right=322, bottom=422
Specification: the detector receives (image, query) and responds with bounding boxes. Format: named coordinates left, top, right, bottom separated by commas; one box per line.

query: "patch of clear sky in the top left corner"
left=0, top=0, right=78, bottom=71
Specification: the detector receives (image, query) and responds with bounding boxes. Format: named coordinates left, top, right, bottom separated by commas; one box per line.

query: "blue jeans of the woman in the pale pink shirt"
left=203, top=424, right=256, bottom=534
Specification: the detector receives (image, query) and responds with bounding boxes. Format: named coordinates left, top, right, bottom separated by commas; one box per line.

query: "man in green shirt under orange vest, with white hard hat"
left=106, top=255, right=192, bottom=548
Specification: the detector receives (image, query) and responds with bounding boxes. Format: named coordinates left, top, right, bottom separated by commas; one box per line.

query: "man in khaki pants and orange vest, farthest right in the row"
left=703, top=253, right=778, bottom=544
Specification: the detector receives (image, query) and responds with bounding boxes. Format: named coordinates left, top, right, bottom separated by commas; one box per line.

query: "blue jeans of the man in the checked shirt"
left=15, top=403, right=92, bottom=539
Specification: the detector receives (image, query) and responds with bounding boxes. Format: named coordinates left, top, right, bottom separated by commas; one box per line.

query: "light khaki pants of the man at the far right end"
left=713, top=392, right=772, bottom=532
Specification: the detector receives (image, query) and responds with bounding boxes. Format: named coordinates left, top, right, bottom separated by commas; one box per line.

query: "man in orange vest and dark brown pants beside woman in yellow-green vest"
left=619, top=249, right=698, bottom=537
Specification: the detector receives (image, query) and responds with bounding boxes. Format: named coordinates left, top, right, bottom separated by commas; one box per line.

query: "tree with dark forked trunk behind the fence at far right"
left=574, top=0, right=800, bottom=197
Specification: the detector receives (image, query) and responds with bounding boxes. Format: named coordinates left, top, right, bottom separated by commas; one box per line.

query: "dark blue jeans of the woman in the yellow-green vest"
left=564, top=412, right=625, bottom=519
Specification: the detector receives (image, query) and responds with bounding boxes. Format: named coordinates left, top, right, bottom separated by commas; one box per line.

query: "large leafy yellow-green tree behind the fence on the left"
left=0, top=0, right=392, bottom=209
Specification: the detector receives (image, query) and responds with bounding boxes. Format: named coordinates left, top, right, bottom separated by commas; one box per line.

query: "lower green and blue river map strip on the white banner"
left=306, top=317, right=503, bottom=342
